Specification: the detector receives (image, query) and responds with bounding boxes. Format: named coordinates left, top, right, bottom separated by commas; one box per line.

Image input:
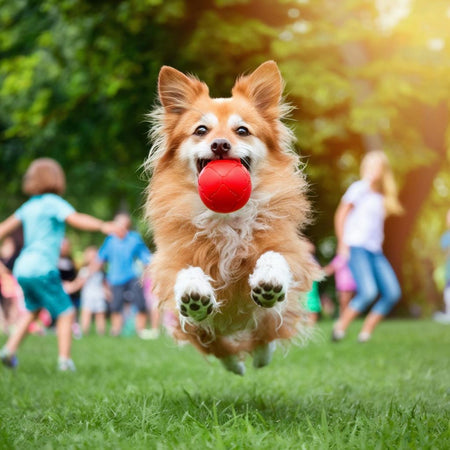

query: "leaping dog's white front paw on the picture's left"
left=175, top=267, right=217, bottom=322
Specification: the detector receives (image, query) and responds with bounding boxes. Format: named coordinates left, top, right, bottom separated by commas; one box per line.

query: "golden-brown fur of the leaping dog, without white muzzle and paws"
left=147, top=62, right=319, bottom=358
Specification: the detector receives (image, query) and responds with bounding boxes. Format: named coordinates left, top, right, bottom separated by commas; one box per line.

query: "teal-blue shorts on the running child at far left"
left=17, top=272, right=73, bottom=318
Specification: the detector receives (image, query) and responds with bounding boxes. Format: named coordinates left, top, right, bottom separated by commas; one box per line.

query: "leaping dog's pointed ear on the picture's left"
left=158, top=66, right=208, bottom=114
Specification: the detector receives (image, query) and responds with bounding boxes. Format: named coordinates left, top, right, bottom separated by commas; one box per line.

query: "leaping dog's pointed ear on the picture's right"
left=232, top=61, right=283, bottom=113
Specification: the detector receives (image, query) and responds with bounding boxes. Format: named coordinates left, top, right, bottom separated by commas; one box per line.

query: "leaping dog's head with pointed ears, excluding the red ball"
left=151, top=61, right=291, bottom=181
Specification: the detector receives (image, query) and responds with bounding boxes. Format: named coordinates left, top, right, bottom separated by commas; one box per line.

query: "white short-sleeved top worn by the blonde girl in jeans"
left=342, top=180, right=385, bottom=252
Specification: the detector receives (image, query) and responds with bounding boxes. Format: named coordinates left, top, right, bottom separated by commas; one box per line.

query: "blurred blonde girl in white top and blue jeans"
left=332, top=151, right=402, bottom=342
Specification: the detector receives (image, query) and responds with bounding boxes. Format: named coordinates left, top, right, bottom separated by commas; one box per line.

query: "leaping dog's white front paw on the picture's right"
left=249, top=252, right=292, bottom=308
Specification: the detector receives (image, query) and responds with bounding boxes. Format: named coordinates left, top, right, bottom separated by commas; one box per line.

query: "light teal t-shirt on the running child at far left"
left=13, top=194, right=75, bottom=277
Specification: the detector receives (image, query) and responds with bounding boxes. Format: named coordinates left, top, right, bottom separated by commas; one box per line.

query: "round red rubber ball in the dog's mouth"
left=198, top=159, right=252, bottom=214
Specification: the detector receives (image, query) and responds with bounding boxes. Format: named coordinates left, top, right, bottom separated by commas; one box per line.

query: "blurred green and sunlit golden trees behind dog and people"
left=0, top=0, right=450, bottom=315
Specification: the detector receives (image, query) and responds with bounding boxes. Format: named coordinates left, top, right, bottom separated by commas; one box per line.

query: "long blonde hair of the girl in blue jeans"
left=361, top=150, right=403, bottom=216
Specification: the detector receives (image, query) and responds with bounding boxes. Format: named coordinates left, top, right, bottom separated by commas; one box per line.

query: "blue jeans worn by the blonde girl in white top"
left=349, top=247, right=401, bottom=316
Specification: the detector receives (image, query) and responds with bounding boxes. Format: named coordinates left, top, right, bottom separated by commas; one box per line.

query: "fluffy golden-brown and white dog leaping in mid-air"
left=147, top=61, right=320, bottom=374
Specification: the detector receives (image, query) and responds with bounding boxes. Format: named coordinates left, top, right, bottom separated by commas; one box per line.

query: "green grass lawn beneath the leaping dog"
left=0, top=321, right=450, bottom=450
